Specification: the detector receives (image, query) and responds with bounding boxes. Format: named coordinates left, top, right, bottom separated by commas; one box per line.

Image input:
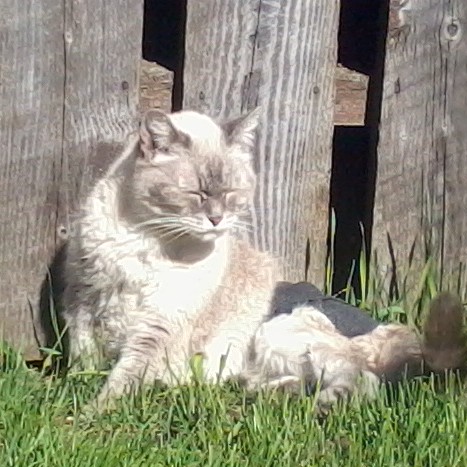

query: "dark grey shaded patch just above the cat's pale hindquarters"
left=271, top=282, right=380, bottom=337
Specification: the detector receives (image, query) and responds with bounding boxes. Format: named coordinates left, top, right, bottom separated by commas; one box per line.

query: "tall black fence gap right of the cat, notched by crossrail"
left=330, top=0, right=389, bottom=293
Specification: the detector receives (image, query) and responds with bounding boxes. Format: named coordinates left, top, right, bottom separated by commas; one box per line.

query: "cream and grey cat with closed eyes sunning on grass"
left=63, top=109, right=467, bottom=411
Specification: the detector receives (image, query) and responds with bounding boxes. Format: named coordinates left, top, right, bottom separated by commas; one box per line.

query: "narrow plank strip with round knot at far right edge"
left=441, top=0, right=467, bottom=284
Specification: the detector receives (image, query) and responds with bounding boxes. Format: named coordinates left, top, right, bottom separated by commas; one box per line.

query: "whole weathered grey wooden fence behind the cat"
left=0, top=0, right=467, bottom=358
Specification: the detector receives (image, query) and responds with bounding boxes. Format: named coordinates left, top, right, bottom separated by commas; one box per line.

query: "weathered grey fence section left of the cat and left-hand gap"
left=0, top=0, right=143, bottom=358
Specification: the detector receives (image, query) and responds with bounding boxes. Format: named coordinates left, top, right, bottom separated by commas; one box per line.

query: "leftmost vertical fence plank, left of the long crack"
left=0, top=0, right=65, bottom=355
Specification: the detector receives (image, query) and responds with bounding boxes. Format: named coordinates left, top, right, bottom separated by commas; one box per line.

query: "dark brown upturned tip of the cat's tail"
left=422, top=292, right=467, bottom=373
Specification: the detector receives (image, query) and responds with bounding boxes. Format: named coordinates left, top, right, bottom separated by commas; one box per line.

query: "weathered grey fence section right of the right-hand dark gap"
left=373, top=0, right=467, bottom=296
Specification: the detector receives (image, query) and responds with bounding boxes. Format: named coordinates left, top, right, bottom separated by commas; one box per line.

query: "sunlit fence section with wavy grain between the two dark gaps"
left=183, top=0, right=339, bottom=285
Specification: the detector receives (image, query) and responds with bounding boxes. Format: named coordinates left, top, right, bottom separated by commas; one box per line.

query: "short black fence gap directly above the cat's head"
left=143, top=0, right=186, bottom=110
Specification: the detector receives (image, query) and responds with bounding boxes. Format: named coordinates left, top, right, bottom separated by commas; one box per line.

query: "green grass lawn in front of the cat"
left=0, top=350, right=467, bottom=467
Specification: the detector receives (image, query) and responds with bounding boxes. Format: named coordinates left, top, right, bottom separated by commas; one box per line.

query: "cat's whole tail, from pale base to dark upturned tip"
left=352, top=292, right=467, bottom=383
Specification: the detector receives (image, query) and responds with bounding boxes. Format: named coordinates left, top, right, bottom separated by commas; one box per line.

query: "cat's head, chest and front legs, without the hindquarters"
left=63, top=110, right=278, bottom=407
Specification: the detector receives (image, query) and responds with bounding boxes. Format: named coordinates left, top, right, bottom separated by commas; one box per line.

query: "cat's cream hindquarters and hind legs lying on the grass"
left=242, top=306, right=422, bottom=409
